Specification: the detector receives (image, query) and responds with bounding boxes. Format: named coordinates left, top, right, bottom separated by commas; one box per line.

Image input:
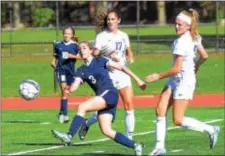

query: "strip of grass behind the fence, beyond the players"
left=1, top=25, right=225, bottom=56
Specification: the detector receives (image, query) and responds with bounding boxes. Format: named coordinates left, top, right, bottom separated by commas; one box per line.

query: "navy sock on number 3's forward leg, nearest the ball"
left=68, top=115, right=84, bottom=137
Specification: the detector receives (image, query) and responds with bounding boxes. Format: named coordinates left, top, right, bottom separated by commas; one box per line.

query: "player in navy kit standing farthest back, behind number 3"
left=51, top=27, right=80, bottom=123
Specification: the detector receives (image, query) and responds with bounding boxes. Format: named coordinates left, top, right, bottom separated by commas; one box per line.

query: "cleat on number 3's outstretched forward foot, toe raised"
left=52, top=129, right=72, bottom=146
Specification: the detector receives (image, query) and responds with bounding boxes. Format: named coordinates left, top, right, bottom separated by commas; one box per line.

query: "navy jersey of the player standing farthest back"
left=54, top=41, right=78, bottom=75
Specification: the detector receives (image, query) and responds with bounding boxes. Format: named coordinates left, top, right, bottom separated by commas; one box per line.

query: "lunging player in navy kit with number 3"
left=52, top=42, right=146, bottom=155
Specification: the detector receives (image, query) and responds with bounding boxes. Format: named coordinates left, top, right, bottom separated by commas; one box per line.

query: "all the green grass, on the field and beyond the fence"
left=1, top=26, right=225, bottom=155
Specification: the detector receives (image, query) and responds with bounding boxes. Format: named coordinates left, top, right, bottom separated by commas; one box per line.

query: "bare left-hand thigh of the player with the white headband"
left=156, top=86, right=172, bottom=116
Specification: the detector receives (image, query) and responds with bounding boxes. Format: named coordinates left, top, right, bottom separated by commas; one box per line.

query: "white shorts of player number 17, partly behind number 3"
left=109, top=70, right=132, bottom=90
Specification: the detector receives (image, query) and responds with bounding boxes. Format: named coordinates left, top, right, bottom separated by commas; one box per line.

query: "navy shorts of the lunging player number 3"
left=97, top=89, right=119, bottom=122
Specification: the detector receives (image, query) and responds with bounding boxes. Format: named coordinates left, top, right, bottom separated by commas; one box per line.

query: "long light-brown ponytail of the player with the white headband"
left=181, top=9, right=199, bottom=41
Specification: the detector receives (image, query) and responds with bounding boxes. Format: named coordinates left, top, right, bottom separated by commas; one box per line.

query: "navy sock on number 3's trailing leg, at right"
left=114, top=132, right=135, bottom=148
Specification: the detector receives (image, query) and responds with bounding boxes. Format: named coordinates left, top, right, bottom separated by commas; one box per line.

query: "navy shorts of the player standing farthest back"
left=55, top=70, right=74, bottom=86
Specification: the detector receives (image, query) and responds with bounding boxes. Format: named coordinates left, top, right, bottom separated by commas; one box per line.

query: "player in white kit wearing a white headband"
left=145, top=9, right=220, bottom=155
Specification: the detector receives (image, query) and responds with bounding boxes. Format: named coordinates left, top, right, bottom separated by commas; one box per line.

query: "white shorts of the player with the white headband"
left=167, top=78, right=195, bottom=100
